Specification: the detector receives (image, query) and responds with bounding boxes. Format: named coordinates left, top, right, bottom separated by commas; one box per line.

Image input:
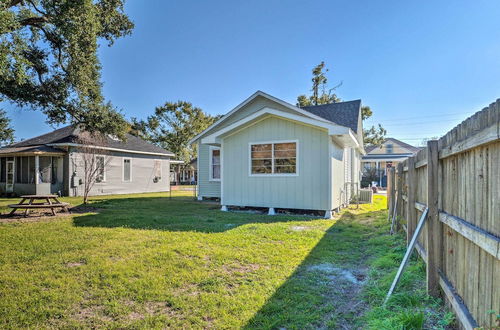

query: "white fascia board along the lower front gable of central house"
left=201, top=108, right=349, bottom=144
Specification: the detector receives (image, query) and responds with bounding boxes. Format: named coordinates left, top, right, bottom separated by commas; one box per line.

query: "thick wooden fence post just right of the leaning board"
left=427, top=140, right=443, bottom=297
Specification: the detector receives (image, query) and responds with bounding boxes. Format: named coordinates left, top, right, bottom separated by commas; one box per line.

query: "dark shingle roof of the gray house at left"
left=8, top=126, right=173, bottom=155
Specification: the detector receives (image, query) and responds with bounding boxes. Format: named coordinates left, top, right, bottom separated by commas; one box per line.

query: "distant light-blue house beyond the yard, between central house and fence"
left=361, top=138, right=420, bottom=187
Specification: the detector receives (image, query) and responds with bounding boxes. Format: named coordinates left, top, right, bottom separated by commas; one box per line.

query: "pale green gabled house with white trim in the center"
left=190, top=91, right=364, bottom=218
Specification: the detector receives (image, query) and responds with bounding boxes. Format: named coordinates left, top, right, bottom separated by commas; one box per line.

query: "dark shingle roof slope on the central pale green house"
left=302, top=100, right=361, bottom=133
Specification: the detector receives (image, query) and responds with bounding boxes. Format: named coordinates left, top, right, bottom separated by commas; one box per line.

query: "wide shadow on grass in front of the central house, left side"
left=73, top=196, right=318, bottom=233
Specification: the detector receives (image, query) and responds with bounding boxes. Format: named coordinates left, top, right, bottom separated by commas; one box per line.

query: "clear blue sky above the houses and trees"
left=7, top=0, right=500, bottom=144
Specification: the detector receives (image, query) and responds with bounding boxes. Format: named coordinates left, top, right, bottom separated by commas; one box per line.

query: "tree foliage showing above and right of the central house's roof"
left=297, top=62, right=387, bottom=146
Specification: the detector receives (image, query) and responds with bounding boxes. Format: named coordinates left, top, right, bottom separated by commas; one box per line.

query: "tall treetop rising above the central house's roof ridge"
left=297, top=62, right=342, bottom=107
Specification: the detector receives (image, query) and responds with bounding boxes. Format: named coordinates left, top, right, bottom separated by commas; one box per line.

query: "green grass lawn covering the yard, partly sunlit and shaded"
left=0, top=192, right=451, bottom=329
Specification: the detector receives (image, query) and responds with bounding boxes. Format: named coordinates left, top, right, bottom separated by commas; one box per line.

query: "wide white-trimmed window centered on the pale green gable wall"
left=250, top=142, right=297, bottom=175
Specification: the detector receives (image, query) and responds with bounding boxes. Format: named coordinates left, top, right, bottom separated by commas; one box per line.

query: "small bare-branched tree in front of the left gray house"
left=73, top=132, right=111, bottom=204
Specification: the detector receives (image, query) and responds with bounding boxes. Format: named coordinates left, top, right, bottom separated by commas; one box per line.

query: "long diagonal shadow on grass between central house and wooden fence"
left=245, top=210, right=391, bottom=329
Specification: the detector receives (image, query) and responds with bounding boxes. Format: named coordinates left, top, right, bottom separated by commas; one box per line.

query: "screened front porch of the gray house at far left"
left=0, top=146, right=65, bottom=195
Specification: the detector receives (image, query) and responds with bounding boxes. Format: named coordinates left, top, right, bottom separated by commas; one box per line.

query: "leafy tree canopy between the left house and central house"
left=132, top=101, right=220, bottom=164
